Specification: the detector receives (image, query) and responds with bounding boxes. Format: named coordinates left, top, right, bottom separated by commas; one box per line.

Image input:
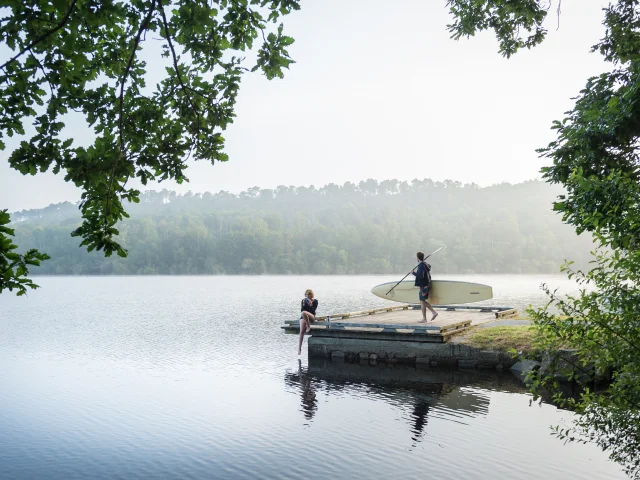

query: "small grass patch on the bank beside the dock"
left=461, top=325, right=535, bottom=352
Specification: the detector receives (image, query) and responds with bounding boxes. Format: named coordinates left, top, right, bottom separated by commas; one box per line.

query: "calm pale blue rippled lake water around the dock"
left=0, top=276, right=625, bottom=480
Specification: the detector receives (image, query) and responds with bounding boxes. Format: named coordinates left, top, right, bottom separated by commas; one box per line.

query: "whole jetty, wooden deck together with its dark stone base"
left=282, top=305, right=517, bottom=370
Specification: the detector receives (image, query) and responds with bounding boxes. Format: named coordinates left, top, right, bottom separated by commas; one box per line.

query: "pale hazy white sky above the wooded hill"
left=0, top=0, right=609, bottom=211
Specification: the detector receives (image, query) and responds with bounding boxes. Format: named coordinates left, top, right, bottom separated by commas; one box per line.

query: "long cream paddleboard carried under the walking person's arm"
left=371, top=280, right=493, bottom=305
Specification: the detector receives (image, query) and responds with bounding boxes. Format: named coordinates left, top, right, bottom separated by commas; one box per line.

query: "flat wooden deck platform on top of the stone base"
left=282, top=305, right=517, bottom=343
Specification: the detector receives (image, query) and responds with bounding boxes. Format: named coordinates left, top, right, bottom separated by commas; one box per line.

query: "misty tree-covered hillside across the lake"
left=12, top=179, right=591, bottom=274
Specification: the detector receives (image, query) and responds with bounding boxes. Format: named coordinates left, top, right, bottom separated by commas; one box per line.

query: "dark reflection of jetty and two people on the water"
left=285, top=358, right=525, bottom=441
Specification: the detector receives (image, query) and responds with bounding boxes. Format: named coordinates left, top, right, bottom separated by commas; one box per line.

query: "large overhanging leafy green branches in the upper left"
left=0, top=0, right=299, bottom=292
